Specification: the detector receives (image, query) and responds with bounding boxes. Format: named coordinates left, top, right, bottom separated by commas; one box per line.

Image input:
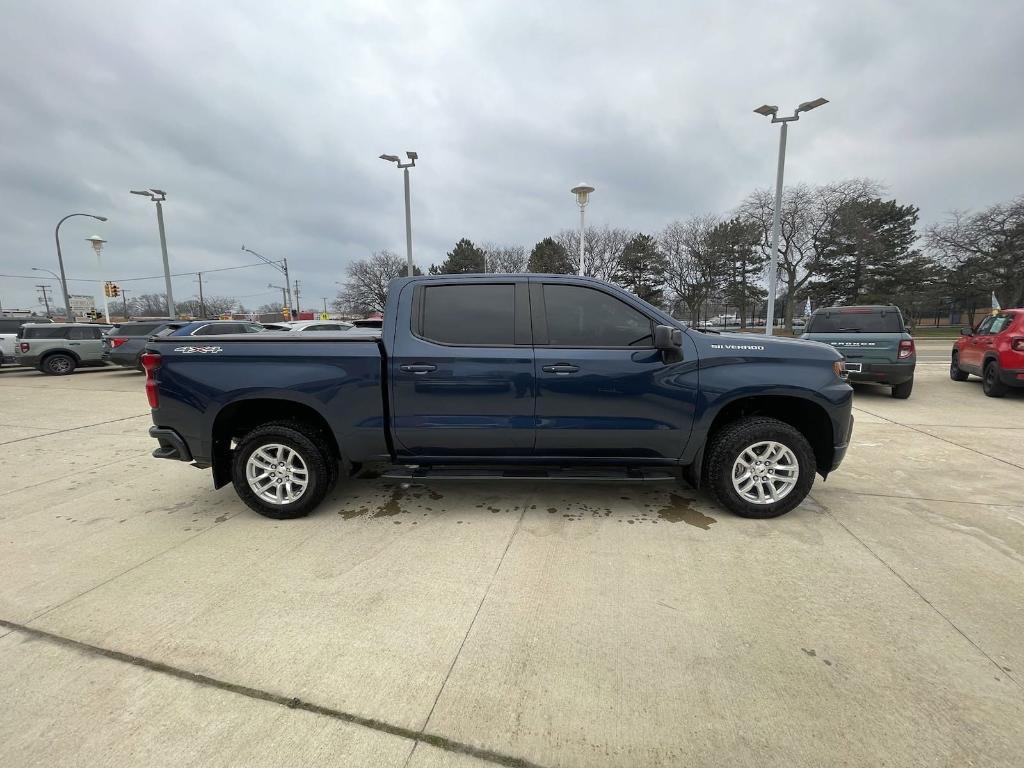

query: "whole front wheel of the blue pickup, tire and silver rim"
left=707, top=417, right=817, bottom=518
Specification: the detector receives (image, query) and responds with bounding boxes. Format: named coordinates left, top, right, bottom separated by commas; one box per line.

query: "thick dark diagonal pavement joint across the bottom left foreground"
left=0, top=618, right=544, bottom=768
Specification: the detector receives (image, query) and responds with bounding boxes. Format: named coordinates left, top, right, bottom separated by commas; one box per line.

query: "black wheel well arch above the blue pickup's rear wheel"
left=212, top=398, right=341, bottom=487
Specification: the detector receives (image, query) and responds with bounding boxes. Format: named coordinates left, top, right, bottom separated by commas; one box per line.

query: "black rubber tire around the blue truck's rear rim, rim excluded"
left=231, top=421, right=338, bottom=520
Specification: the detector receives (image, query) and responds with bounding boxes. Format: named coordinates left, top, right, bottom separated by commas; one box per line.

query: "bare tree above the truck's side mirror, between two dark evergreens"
left=658, top=214, right=729, bottom=324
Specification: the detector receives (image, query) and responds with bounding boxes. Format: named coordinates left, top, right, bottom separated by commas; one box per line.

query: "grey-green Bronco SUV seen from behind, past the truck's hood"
left=800, top=306, right=918, bottom=399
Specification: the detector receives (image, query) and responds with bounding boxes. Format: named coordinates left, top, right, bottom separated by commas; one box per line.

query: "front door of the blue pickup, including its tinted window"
left=530, top=279, right=697, bottom=460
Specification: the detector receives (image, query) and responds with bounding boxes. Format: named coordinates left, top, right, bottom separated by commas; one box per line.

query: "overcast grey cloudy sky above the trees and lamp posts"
left=0, top=0, right=1024, bottom=308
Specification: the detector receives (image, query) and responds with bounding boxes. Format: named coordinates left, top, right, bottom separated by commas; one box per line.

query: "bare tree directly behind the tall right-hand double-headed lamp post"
left=737, top=178, right=883, bottom=333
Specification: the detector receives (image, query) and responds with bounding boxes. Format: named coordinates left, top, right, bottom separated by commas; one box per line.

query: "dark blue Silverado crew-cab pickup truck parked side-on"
left=142, top=274, right=853, bottom=519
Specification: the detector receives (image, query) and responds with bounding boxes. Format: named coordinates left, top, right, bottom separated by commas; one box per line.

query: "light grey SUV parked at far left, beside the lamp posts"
left=15, top=323, right=105, bottom=376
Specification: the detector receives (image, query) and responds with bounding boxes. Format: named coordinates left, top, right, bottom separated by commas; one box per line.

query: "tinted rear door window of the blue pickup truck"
left=420, top=284, right=515, bottom=346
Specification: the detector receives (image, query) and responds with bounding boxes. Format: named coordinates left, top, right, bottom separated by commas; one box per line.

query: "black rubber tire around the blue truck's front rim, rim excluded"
left=705, top=416, right=817, bottom=519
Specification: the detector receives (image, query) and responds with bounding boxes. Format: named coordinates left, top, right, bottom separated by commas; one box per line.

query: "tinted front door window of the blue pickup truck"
left=544, top=283, right=654, bottom=347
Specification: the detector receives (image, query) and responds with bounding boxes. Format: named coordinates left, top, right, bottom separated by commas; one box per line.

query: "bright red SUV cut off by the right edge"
left=949, top=308, right=1024, bottom=397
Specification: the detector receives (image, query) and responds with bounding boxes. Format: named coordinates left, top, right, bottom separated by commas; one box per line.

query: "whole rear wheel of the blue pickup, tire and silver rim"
left=231, top=422, right=338, bottom=520
